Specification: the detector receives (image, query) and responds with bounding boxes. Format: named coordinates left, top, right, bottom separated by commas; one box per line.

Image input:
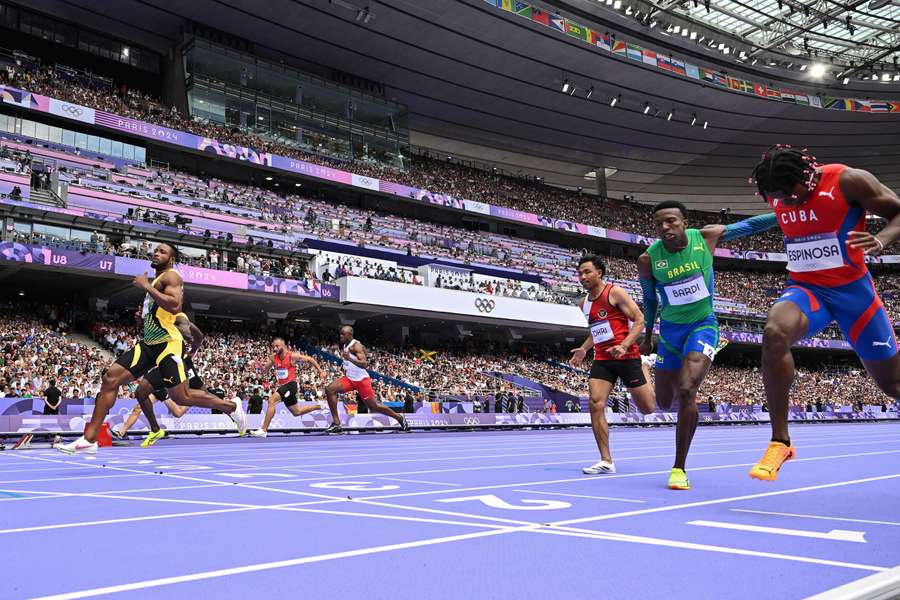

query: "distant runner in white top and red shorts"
left=325, top=325, right=409, bottom=433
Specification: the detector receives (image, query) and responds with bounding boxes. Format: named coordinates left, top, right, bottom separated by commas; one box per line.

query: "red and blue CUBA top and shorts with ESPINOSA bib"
left=768, top=164, right=897, bottom=361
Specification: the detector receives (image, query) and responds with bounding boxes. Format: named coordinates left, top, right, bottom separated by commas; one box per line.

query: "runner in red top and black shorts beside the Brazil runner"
left=569, top=256, right=656, bottom=475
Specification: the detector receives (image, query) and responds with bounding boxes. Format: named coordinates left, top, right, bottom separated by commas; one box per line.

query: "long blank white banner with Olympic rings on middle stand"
left=338, top=277, right=587, bottom=328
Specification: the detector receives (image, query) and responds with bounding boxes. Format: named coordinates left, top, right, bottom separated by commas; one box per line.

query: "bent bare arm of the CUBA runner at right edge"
left=841, top=169, right=900, bottom=255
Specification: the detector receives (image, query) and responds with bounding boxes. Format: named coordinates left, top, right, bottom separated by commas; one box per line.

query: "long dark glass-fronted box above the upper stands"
left=184, top=38, right=409, bottom=168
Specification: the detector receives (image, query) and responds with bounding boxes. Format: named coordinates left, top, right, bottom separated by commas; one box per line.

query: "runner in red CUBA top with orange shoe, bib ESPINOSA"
left=750, top=146, right=900, bottom=481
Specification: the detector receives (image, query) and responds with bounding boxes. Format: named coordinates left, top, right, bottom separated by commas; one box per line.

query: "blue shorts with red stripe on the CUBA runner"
left=777, top=275, right=897, bottom=360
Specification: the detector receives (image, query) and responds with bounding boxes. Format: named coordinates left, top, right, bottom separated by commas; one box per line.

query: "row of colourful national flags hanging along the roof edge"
left=485, top=0, right=900, bottom=113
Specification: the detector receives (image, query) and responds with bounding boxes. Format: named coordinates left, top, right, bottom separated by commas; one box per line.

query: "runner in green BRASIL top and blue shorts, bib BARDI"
left=638, top=201, right=777, bottom=490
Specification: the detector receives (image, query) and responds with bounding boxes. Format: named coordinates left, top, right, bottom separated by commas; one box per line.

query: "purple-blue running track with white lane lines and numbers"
left=0, top=423, right=900, bottom=600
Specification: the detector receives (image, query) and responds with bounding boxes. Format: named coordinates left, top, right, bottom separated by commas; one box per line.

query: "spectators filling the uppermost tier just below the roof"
left=0, top=61, right=896, bottom=252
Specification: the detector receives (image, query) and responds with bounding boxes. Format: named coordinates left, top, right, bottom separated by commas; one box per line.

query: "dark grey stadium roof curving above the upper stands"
left=22, top=0, right=900, bottom=212
